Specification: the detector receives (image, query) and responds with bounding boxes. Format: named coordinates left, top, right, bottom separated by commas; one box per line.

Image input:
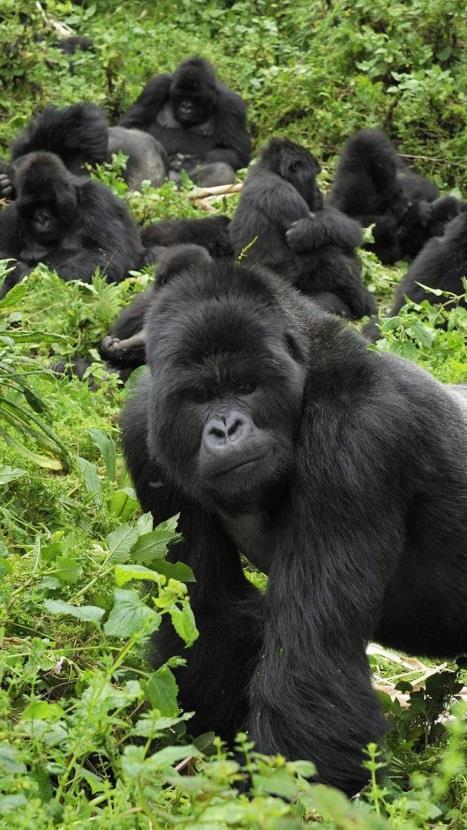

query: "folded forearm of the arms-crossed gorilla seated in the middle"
left=286, top=208, right=362, bottom=253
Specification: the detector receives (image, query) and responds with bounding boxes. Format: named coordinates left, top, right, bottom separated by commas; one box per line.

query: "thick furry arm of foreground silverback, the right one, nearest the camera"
left=250, top=394, right=405, bottom=793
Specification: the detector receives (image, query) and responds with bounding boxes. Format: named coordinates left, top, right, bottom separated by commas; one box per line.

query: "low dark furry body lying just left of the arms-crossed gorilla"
left=141, top=216, right=233, bottom=264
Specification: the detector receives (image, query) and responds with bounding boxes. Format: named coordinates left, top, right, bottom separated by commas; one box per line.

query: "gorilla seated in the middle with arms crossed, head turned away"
left=230, top=138, right=376, bottom=318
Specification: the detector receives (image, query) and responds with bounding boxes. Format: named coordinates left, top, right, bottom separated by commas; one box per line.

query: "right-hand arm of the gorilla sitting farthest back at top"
left=204, top=84, right=251, bottom=170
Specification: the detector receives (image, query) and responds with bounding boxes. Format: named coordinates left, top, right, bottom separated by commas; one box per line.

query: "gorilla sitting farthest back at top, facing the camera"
left=120, top=57, right=251, bottom=187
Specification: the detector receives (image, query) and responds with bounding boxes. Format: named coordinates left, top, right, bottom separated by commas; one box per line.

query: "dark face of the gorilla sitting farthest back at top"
left=170, top=66, right=216, bottom=128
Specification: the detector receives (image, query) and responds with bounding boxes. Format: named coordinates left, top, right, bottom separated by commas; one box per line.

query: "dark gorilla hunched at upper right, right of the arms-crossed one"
left=329, top=130, right=461, bottom=264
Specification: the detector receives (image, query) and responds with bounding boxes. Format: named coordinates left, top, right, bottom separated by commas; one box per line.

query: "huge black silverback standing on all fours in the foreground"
left=123, top=262, right=467, bottom=793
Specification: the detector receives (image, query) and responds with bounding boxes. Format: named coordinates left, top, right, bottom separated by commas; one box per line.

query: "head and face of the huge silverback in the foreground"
left=147, top=266, right=304, bottom=515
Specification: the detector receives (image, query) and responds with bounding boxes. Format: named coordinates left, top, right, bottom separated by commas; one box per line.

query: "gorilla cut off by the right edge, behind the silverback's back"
left=390, top=211, right=467, bottom=317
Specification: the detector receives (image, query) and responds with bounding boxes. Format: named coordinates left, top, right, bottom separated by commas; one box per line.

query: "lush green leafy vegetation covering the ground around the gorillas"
left=0, top=0, right=467, bottom=830
